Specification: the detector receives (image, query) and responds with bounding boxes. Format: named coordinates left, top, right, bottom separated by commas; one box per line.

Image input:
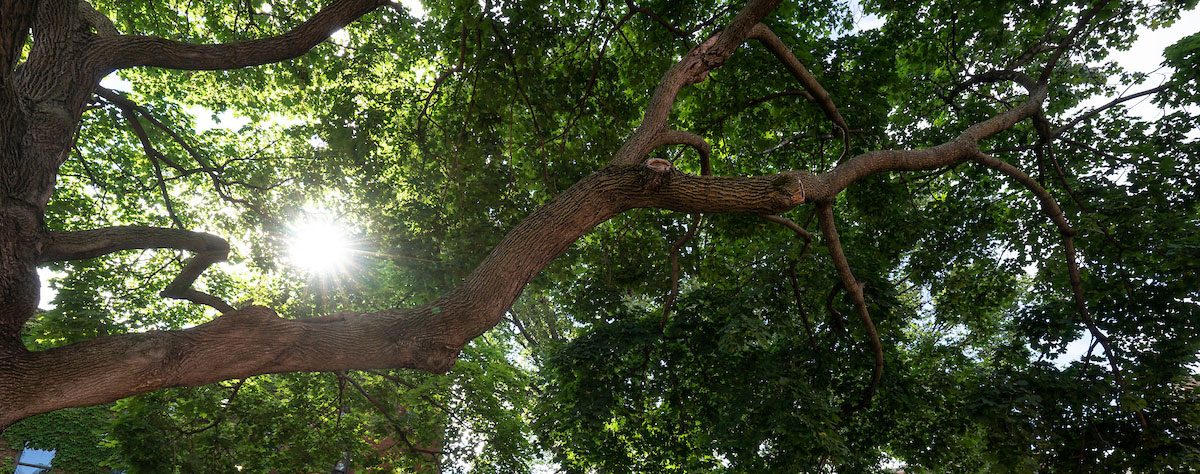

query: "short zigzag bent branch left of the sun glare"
left=38, top=226, right=233, bottom=313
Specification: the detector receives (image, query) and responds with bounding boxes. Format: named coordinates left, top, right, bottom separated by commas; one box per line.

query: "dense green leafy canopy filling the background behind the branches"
left=4, top=0, right=1200, bottom=473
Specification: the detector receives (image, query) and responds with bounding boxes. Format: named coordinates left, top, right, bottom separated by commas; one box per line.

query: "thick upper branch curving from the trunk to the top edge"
left=92, top=0, right=389, bottom=71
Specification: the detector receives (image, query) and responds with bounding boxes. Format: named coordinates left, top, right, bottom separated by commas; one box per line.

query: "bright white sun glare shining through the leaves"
left=288, top=217, right=354, bottom=275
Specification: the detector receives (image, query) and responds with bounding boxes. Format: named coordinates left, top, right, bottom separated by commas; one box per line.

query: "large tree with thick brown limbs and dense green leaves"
left=0, top=0, right=1200, bottom=472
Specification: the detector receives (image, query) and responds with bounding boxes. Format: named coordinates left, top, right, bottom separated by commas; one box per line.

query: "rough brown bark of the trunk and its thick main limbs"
left=0, top=0, right=1045, bottom=430
